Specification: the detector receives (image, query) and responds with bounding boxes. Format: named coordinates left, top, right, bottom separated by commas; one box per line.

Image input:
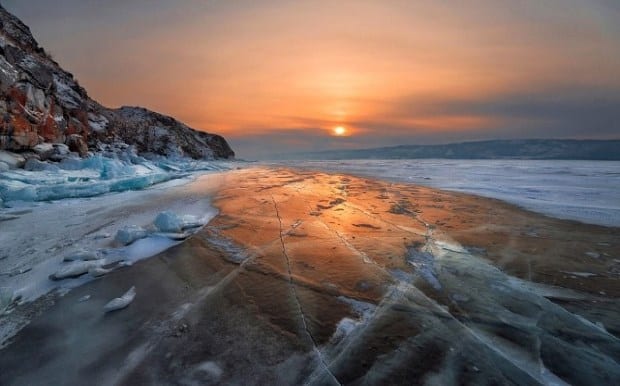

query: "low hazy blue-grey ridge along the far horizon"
left=281, top=139, right=620, bottom=161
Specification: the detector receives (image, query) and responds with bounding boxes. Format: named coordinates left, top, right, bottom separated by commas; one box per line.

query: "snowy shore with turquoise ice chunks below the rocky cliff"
left=0, top=163, right=234, bottom=345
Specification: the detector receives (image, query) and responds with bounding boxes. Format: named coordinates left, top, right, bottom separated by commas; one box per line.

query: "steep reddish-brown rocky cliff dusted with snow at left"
left=0, top=5, right=234, bottom=159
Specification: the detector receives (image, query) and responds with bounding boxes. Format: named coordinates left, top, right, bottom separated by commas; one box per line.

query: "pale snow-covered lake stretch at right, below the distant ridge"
left=286, top=159, right=620, bottom=227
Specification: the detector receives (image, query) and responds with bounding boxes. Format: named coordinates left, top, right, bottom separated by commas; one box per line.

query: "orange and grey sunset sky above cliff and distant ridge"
left=1, top=0, right=620, bottom=159
